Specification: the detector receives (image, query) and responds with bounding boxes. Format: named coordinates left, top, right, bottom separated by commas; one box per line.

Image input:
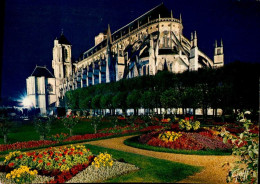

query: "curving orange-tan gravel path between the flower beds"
left=86, top=136, right=238, bottom=184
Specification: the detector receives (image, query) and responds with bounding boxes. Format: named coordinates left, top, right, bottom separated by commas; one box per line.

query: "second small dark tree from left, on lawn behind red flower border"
left=34, top=117, right=53, bottom=140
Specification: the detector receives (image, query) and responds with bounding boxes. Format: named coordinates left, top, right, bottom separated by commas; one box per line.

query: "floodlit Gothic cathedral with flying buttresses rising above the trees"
left=27, top=4, right=224, bottom=114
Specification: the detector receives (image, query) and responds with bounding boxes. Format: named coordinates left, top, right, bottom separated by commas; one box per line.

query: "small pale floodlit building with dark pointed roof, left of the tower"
left=26, top=66, right=57, bottom=114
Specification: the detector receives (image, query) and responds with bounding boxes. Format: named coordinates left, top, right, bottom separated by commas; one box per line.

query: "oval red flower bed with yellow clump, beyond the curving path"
left=139, top=130, right=232, bottom=150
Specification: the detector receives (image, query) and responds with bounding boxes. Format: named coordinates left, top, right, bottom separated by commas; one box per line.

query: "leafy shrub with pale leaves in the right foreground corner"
left=221, top=112, right=259, bottom=183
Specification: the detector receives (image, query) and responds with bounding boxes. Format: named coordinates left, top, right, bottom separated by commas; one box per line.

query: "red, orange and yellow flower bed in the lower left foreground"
left=0, top=145, right=136, bottom=183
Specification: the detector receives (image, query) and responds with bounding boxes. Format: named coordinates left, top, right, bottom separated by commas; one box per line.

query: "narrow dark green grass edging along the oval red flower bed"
left=124, top=136, right=232, bottom=155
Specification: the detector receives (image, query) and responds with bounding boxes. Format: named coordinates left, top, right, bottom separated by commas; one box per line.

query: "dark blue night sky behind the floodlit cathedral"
left=0, top=0, right=260, bottom=98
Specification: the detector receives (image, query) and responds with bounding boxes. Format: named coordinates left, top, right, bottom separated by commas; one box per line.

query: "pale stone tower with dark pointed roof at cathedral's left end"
left=52, top=32, right=72, bottom=106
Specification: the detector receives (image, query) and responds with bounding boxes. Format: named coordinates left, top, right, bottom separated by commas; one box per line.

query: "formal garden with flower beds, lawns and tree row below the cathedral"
left=0, top=62, right=259, bottom=183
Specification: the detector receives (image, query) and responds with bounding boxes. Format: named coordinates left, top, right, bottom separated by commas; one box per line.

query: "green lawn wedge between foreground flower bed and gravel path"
left=85, top=144, right=202, bottom=183
